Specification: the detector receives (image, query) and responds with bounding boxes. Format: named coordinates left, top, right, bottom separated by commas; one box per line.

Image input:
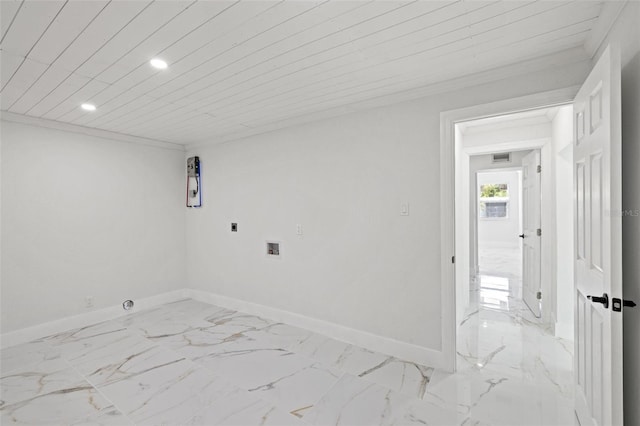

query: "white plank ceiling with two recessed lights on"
left=0, top=0, right=603, bottom=144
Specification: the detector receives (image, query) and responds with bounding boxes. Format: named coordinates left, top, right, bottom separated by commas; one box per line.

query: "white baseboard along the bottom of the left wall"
left=0, top=289, right=188, bottom=349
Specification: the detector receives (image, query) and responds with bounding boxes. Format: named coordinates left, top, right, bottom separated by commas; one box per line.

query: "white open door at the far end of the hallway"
left=520, top=150, right=541, bottom=318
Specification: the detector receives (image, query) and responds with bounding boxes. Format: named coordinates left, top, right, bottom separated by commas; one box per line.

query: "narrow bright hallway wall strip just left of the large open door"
left=551, top=105, right=574, bottom=340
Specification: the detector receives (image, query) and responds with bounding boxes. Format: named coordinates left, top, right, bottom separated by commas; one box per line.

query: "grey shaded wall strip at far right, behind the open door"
left=594, top=1, right=640, bottom=425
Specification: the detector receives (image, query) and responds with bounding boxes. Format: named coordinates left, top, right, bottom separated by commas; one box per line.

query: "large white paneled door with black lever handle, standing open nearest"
left=573, top=47, right=623, bottom=426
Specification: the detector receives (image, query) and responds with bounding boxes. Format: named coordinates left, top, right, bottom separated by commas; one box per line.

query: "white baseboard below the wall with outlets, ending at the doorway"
left=186, top=289, right=446, bottom=368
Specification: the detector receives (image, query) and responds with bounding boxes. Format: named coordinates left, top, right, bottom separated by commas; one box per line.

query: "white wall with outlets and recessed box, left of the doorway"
left=187, top=57, right=588, bottom=360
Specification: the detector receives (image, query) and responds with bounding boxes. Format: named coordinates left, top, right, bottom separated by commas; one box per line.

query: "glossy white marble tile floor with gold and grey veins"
left=0, top=292, right=573, bottom=426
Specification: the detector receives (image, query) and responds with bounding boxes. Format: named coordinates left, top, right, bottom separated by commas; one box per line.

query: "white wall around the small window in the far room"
left=476, top=171, right=521, bottom=250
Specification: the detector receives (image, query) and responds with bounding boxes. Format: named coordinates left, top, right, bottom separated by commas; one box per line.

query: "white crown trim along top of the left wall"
left=0, top=111, right=185, bottom=152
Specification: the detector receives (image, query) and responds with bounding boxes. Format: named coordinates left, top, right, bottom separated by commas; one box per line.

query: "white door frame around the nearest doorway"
left=440, top=86, right=580, bottom=372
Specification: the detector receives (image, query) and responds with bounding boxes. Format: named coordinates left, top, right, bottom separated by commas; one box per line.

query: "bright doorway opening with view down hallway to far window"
left=442, top=105, right=573, bottom=423
